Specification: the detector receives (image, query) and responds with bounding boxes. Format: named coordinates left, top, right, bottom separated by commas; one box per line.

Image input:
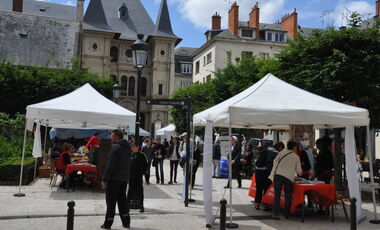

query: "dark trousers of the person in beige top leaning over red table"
left=273, top=175, right=293, bottom=217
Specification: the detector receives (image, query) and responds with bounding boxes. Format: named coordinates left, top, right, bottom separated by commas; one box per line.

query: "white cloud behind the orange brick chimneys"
left=163, top=0, right=284, bottom=29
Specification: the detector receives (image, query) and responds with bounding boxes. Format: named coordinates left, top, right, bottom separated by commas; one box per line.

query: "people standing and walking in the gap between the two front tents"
left=101, top=130, right=201, bottom=229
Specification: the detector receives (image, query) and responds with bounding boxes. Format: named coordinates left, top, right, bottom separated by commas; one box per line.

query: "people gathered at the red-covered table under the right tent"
left=255, top=138, right=334, bottom=219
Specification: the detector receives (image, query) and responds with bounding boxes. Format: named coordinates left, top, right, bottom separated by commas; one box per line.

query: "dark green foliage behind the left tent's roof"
left=0, top=62, right=112, bottom=115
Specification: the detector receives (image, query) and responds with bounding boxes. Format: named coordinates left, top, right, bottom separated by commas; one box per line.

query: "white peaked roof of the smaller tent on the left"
left=26, top=83, right=136, bottom=129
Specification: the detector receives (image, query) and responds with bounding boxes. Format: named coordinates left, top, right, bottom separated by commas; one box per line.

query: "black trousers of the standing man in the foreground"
left=104, top=181, right=131, bottom=227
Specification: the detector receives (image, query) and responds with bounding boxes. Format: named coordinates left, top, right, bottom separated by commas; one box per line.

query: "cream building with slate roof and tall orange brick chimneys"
left=193, top=2, right=313, bottom=83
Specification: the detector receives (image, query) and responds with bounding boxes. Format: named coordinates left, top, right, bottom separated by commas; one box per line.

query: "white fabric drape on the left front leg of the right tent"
left=203, top=121, right=214, bottom=225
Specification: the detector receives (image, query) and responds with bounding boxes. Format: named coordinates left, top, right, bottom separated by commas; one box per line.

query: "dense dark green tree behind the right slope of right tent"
left=277, top=23, right=380, bottom=128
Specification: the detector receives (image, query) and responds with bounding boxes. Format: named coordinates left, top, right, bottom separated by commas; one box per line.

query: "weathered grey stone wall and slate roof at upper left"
left=0, top=0, right=83, bottom=68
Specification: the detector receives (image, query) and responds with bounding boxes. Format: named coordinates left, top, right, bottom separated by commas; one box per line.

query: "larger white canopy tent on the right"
left=193, top=74, right=376, bottom=225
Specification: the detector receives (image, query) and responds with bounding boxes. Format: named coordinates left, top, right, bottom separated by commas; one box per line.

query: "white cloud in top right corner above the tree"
left=331, top=0, right=375, bottom=27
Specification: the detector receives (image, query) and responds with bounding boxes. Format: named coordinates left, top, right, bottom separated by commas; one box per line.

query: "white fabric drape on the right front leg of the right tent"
left=344, top=126, right=363, bottom=222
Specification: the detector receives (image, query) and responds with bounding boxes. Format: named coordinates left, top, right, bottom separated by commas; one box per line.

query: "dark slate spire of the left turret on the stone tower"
left=83, top=0, right=113, bottom=32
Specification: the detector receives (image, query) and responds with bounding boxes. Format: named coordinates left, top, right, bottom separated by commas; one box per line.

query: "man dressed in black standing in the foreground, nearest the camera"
left=101, top=130, right=131, bottom=229
